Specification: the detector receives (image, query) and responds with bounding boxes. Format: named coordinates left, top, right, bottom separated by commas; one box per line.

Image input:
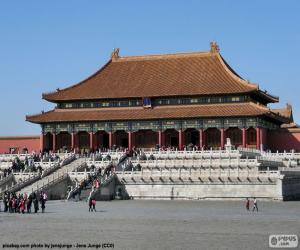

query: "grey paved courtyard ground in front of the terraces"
left=0, top=201, right=300, bottom=249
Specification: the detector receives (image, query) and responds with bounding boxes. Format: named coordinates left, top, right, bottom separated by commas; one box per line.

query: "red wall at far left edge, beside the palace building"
left=0, top=136, right=40, bottom=154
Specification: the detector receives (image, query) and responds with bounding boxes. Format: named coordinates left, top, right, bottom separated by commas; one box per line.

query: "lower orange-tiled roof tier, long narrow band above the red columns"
left=26, top=102, right=270, bottom=123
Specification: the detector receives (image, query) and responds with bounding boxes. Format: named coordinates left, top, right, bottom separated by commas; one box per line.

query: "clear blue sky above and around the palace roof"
left=0, top=0, right=300, bottom=135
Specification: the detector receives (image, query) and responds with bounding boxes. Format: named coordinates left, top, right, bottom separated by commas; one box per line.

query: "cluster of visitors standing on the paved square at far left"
left=0, top=192, right=48, bottom=214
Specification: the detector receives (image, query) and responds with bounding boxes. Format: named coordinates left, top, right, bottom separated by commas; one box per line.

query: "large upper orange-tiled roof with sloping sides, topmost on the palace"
left=43, top=48, right=258, bottom=102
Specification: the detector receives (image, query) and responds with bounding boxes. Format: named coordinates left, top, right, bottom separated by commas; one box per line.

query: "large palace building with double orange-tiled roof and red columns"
left=26, top=42, right=296, bottom=151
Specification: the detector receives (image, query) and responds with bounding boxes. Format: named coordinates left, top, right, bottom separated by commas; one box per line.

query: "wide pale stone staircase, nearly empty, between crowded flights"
left=18, top=158, right=85, bottom=194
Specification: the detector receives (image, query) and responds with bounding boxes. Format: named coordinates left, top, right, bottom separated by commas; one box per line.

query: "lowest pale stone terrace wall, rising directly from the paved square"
left=117, top=180, right=283, bottom=200
